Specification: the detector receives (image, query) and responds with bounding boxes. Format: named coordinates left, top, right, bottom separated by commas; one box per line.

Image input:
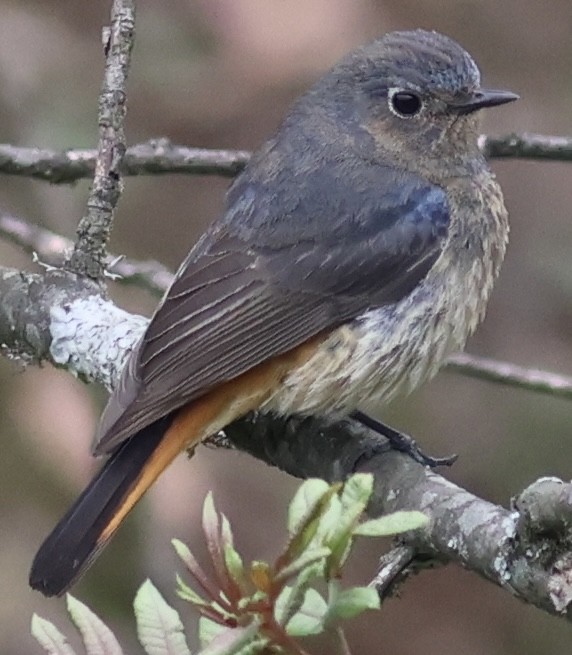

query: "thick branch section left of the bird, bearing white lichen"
left=0, top=268, right=148, bottom=389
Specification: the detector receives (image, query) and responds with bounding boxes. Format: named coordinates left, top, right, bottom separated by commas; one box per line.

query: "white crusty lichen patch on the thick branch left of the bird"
left=50, top=295, right=149, bottom=389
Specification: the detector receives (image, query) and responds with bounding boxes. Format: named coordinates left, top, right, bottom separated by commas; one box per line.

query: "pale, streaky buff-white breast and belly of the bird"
left=261, top=171, right=508, bottom=415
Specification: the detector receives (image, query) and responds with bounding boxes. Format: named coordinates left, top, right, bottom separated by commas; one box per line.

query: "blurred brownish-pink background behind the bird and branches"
left=0, top=0, right=572, bottom=655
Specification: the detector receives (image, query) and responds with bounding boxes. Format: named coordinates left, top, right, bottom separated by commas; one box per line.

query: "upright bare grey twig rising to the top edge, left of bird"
left=66, top=0, right=135, bottom=280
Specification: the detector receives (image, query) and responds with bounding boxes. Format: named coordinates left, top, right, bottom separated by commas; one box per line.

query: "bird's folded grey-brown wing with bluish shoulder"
left=95, top=170, right=449, bottom=454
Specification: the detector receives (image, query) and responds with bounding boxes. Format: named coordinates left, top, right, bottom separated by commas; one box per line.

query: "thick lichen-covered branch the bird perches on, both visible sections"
left=0, top=262, right=572, bottom=618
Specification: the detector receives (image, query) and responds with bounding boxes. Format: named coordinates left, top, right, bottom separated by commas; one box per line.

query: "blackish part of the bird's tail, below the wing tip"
left=30, top=420, right=169, bottom=596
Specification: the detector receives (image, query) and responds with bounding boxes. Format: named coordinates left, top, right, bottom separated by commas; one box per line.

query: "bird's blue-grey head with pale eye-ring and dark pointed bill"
left=308, top=30, right=518, bottom=178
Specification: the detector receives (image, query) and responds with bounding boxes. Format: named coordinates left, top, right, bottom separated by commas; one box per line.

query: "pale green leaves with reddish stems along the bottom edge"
left=32, top=474, right=427, bottom=655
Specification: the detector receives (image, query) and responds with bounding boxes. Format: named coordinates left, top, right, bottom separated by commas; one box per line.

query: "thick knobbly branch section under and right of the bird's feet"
left=225, top=415, right=572, bottom=620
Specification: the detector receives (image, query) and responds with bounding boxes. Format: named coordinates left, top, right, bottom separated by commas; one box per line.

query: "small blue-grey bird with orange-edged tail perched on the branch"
left=29, top=30, right=518, bottom=596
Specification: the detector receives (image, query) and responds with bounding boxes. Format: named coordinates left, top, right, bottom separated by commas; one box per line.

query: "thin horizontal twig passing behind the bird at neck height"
left=0, top=134, right=572, bottom=184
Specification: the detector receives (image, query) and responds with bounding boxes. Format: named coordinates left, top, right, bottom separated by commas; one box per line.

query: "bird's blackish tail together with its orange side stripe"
left=30, top=348, right=316, bottom=596
